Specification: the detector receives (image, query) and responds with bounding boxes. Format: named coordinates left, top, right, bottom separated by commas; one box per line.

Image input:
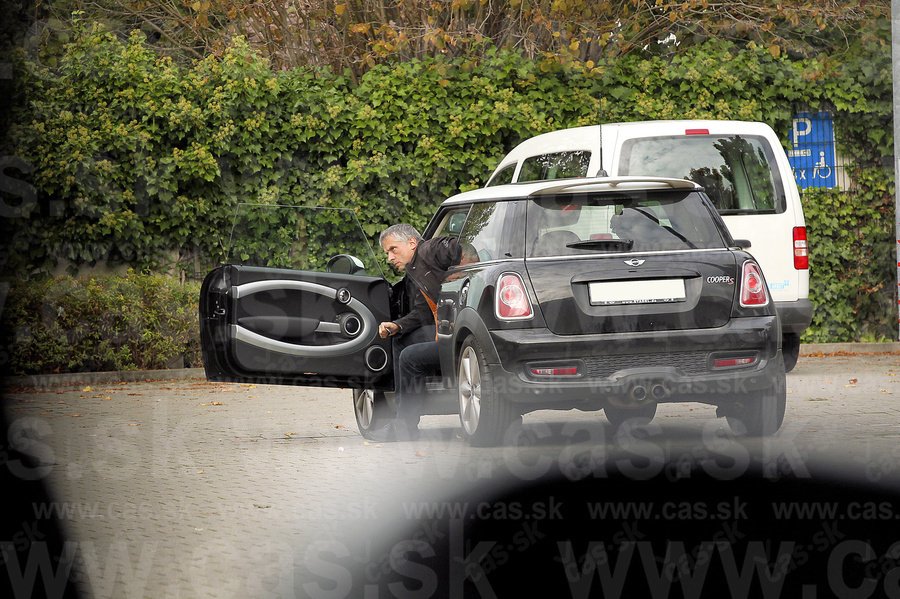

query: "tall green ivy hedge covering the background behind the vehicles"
left=0, top=23, right=896, bottom=352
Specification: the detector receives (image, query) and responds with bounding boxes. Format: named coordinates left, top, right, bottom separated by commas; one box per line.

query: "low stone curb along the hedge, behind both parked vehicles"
left=3, top=342, right=900, bottom=389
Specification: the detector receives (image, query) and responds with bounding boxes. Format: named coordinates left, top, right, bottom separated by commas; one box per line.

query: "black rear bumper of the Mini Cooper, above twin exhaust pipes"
left=491, top=316, right=784, bottom=410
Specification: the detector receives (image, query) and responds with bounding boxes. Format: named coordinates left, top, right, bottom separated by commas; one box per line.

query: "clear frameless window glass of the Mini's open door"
left=227, top=204, right=384, bottom=276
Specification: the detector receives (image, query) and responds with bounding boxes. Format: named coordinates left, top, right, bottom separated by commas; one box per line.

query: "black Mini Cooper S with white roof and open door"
left=200, top=177, right=786, bottom=445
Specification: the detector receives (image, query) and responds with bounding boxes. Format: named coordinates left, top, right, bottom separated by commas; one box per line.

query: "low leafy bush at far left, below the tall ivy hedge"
left=0, top=271, right=202, bottom=375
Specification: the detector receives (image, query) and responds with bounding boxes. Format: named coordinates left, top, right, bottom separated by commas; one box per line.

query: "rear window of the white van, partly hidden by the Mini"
left=618, top=135, right=785, bottom=214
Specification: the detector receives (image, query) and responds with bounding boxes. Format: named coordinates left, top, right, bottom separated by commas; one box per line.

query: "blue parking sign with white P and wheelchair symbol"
left=787, top=112, right=837, bottom=189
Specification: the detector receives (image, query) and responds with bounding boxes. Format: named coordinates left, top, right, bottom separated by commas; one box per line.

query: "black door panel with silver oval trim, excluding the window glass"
left=200, top=265, right=393, bottom=389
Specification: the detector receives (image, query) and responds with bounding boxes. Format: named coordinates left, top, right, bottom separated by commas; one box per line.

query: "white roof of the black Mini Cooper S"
left=441, top=176, right=703, bottom=206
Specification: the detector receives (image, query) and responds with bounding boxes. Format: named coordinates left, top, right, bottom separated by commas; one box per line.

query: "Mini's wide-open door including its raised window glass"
left=200, top=204, right=393, bottom=390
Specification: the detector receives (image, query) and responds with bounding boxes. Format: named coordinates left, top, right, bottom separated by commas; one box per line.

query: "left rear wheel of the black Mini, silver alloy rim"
left=456, top=337, right=521, bottom=447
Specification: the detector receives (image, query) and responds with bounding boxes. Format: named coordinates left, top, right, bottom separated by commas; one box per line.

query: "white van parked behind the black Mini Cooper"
left=486, top=120, right=812, bottom=370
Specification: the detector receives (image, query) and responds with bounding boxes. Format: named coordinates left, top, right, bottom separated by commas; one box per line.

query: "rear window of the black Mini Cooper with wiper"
left=526, top=191, right=725, bottom=257
